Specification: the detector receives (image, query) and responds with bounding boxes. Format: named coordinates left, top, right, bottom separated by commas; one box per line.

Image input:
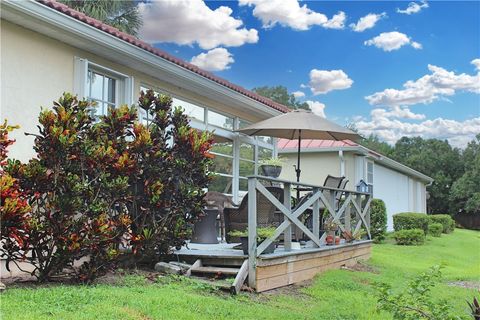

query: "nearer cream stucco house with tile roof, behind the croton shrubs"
left=0, top=0, right=288, bottom=202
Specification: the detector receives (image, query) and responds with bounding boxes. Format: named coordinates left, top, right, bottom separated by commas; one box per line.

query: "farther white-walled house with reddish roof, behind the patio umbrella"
left=278, top=139, right=433, bottom=231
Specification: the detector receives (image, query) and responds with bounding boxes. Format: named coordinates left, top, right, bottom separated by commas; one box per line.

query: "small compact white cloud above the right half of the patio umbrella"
left=309, top=69, right=353, bottom=95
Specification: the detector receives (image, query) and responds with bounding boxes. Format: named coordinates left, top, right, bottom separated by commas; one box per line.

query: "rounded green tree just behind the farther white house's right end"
left=392, top=137, right=463, bottom=213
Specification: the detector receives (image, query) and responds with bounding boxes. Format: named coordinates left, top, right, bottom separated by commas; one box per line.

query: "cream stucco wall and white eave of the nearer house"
left=0, top=20, right=265, bottom=161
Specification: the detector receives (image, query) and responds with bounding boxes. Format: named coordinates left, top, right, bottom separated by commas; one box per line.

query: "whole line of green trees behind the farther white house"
left=361, top=134, right=480, bottom=215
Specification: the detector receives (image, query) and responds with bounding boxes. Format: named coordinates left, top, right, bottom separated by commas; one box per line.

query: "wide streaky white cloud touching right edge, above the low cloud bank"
left=365, top=59, right=480, bottom=106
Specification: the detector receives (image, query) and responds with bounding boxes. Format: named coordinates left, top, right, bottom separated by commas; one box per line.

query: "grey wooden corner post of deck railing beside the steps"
left=248, top=177, right=257, bottom=288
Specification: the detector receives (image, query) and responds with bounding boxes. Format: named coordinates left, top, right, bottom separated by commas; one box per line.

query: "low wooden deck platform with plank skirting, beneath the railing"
left=174, top=240, right=372, bottom=292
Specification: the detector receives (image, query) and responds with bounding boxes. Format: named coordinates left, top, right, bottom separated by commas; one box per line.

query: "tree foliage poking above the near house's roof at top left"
left=60, top=0, right=142, bottom=36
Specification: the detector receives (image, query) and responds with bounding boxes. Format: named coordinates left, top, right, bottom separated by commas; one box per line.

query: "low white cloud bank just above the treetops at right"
left=355, top=109, right=480, bottom=147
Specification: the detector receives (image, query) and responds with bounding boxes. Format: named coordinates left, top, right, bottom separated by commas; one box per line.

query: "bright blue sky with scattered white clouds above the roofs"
left=137, top=0, right=480, bottom=146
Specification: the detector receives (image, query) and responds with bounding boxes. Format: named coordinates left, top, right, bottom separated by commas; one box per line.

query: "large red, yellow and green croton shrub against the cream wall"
left=0, top=91, right=211, bottom=281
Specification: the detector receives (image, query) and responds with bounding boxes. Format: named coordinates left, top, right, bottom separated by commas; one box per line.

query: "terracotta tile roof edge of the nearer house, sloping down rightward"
left=37, top=0, right=289, bottom=112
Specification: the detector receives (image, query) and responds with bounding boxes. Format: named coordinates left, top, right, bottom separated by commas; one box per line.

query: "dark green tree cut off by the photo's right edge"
left=450, top=134, right=480, bottom=213
